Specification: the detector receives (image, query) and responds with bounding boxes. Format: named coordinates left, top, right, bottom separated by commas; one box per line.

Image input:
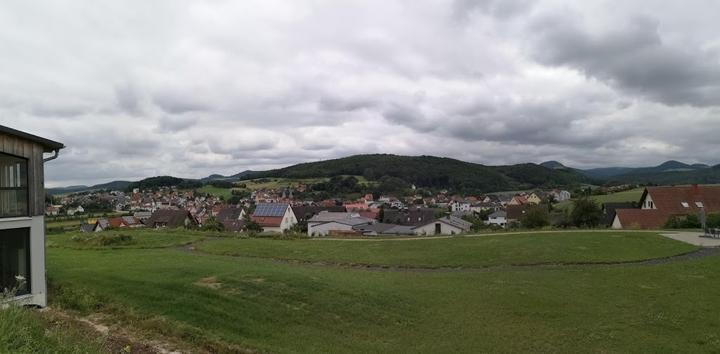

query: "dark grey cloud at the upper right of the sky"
left=531, top=13, right=720, bottom=106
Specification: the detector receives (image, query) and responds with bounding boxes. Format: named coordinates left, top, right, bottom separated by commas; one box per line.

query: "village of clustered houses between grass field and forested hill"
left=46, top=186, right=571, bottom=237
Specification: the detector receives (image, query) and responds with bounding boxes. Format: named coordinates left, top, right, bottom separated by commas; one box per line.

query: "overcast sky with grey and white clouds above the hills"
left=0, top=0, right=720, bottom=187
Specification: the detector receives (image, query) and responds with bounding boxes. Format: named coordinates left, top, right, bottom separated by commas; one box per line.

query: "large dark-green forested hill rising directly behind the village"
left=242, top=154, right=591, bottom=193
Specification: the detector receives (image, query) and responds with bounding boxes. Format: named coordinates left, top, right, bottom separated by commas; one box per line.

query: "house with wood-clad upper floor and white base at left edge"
left=0, top=126, right=65, bottom=307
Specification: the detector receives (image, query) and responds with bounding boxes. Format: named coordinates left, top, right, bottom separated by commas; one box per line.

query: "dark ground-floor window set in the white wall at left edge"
left=0, top=229, right=30, bottom=295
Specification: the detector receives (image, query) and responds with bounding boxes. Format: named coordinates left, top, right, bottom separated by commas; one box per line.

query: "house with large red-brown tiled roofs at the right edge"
left=612, top=185, right=720, bottom=229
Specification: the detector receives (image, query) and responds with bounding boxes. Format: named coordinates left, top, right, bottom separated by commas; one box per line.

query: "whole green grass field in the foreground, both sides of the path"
left=36, top=231, right=720, bottom=353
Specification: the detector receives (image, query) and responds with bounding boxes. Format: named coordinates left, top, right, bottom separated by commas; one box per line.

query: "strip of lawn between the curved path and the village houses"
left=193, top=232, right=696, bottom=267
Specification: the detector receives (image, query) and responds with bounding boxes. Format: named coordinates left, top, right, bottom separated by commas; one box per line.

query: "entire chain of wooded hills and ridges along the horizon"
left=53, top=154, right=720, bottom=195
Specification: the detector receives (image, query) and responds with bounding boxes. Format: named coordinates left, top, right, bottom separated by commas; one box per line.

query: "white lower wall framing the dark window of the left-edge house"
left=0, top=216, right=47, bottom=307
